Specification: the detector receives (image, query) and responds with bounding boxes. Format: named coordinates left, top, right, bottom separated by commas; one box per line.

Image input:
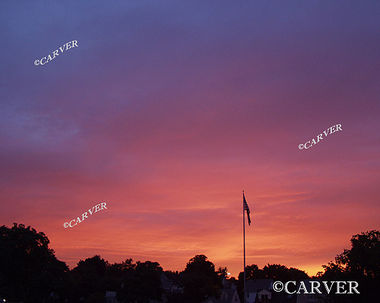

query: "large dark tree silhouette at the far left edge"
left=0, top=223, right=68, bottom=302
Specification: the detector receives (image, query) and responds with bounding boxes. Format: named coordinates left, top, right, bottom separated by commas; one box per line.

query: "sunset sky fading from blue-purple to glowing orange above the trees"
left=0, top=0, right=380, bottom=276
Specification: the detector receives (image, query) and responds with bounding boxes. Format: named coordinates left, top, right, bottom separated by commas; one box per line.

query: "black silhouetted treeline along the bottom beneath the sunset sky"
left=0, top=223, right=380, bottom=303
